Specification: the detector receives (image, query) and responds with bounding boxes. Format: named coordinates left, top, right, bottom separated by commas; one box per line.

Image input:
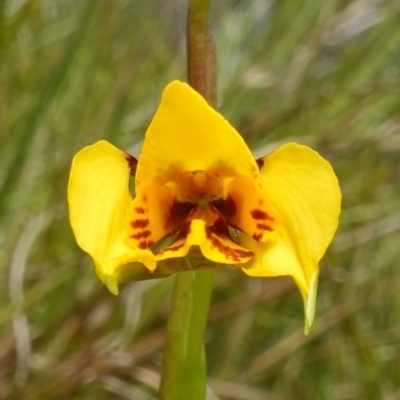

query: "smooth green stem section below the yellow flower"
left=160, top=271, right=214, bottom=400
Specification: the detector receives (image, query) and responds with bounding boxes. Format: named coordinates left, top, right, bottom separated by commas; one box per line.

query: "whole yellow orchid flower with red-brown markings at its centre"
left=68, top=81, right=341, bottom=330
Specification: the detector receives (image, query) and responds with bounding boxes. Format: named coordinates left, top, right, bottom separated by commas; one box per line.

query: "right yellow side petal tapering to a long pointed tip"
left=241, top=143, right=341, bottom=331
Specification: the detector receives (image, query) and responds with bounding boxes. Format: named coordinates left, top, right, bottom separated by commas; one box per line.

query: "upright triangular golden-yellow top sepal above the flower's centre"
left=136, top=81, right=261, bottom=188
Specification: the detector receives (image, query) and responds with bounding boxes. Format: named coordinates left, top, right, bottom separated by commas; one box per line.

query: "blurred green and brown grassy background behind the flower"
left=0, top=0, right=400, bottom=400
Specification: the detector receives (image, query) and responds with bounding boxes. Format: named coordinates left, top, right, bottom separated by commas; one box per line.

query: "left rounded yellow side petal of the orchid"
left=68, top=140, right=156, bottom=293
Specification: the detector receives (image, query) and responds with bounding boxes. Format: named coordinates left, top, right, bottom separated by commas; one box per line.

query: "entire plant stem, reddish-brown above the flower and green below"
left=160, top=0, right=216, bottom=400
